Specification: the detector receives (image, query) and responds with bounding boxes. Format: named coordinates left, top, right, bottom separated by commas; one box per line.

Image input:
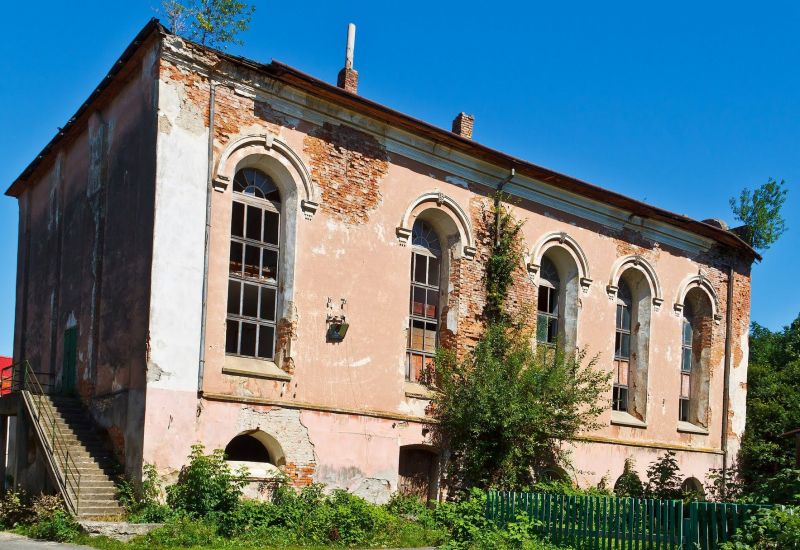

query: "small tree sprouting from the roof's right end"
left=729, top=178, right=788, bottom=250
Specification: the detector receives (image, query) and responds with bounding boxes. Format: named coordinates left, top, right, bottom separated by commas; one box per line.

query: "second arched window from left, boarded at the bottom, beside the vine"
left=406, top=219, right=442, bottom=382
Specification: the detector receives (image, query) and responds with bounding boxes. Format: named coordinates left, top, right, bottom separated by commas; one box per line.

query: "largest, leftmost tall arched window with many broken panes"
left=225, top=168, right=281, bottom=359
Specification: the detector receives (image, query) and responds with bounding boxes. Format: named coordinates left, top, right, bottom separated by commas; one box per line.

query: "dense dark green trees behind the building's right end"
left=739, top=316, right=800, bottom=484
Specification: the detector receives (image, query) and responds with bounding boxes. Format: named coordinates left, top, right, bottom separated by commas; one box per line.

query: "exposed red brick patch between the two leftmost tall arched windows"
left=303, top=122, right=389, bottom=224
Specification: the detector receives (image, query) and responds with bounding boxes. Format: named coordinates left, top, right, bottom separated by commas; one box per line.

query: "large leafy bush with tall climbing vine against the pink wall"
left=432, top=199, right=609, bottom=489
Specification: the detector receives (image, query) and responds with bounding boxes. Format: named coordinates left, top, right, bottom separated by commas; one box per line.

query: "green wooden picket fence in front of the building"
left=486, top=491, right=772, bottom=550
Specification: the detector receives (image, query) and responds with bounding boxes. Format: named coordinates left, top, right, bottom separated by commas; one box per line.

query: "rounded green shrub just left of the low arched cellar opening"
left=167, top=444, right=247, bottom=518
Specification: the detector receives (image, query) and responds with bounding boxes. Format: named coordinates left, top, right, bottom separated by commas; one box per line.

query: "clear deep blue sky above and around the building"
left=0, top=0, right=800, bottom=355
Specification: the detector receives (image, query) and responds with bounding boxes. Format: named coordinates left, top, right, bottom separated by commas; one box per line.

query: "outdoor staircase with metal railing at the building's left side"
left=0, top=361, right=124, bottom=518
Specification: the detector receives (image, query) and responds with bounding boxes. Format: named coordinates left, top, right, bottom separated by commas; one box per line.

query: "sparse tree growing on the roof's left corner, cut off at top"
left=161, top=0, right=256, bottom=49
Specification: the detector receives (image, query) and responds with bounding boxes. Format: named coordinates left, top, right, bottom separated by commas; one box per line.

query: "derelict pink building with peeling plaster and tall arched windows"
left=0, top=20, right=758, bottom=514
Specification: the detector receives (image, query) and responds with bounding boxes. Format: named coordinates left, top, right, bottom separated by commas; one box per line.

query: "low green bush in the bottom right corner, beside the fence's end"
left=720, top=507, right=800, bottom=550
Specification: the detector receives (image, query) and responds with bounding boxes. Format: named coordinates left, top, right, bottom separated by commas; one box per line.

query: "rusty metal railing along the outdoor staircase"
left=12, top=361, right=81, bottom=515
